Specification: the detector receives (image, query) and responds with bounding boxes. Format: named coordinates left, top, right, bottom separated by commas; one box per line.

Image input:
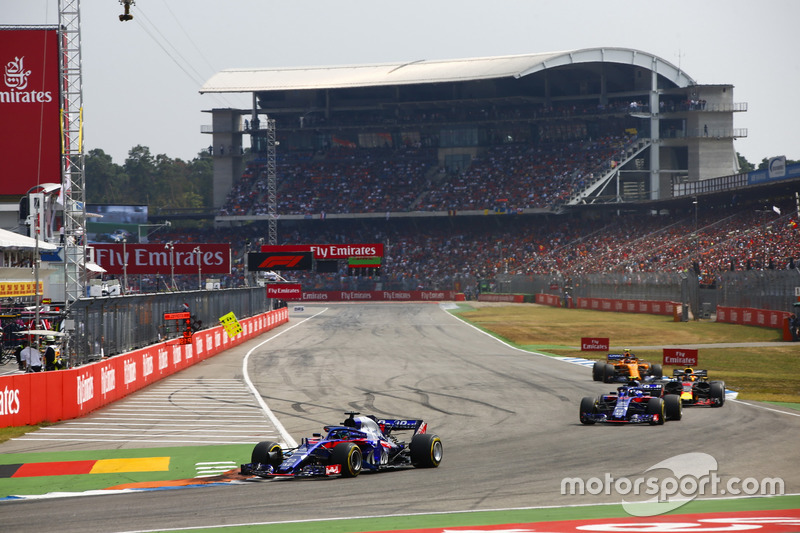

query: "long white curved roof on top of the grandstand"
left=200, top=48, right=696, bottom=93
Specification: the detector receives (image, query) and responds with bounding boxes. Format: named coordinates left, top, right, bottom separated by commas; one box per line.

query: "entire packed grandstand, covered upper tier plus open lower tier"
left=189, top=48, right=800, bottom=306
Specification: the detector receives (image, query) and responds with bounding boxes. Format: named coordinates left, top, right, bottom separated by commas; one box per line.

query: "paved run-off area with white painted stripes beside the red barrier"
left=14, top=377, right=281, bottom=448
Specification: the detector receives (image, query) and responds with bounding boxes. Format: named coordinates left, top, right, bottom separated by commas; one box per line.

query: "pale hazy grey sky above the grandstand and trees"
left=0, top=0, right=800, bottom=164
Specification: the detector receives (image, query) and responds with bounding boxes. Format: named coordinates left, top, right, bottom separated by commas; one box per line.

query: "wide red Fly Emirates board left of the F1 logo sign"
left=92, top=243, right=231, bottom=275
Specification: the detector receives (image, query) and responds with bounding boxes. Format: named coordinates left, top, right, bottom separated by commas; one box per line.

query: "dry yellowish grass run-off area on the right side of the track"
left=460, top=305, right=800, bottom=403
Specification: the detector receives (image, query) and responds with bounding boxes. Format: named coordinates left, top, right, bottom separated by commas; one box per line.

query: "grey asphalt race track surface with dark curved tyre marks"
left=0, top=304, right=800, bottom=533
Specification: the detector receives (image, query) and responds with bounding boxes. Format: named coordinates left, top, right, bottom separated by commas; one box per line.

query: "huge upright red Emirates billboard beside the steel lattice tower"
left=0, top=29, right=61, bottom=195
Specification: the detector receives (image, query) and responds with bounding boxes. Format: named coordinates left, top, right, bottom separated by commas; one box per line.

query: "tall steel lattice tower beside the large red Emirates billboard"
left=58, top=0, right=86, bottom=362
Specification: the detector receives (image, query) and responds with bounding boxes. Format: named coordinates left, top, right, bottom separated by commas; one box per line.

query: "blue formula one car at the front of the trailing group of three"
left=580, top=382, right=683, bottom=425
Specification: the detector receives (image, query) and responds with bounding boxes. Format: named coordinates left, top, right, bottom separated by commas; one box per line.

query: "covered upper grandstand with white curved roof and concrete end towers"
left=201, top=48, right=747, bottom=221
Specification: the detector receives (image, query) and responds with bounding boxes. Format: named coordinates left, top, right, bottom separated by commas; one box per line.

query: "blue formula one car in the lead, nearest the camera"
left=241, top=412, right=444, bottom=478
